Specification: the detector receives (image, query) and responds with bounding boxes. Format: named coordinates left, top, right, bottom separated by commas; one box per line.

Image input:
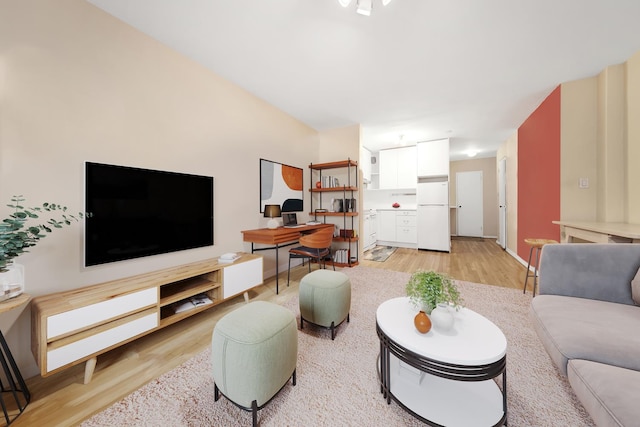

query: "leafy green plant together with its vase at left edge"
left=0, top=196, right=90, bottom=301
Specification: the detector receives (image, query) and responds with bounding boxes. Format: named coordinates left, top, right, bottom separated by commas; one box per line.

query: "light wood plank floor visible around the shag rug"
left=12, top=238, right=531, bottom=426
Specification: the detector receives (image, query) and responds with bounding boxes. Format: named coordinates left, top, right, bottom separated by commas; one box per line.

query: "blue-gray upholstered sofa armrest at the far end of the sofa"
left=538, top=243, right=640, bottom=304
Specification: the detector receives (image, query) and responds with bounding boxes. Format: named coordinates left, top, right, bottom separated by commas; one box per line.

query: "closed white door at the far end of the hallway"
left=456, top=171, right=484, bottom=237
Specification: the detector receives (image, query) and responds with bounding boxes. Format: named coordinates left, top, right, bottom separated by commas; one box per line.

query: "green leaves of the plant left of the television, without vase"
left=0, top=196, right=91, bottom=272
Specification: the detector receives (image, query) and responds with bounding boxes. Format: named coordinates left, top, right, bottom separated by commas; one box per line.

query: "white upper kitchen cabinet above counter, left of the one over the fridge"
left=379, top=146, right=418, bottom=189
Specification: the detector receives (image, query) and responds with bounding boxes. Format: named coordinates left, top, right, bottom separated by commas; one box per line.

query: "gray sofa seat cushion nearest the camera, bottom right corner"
left=568, top=359, right=640, bottom=427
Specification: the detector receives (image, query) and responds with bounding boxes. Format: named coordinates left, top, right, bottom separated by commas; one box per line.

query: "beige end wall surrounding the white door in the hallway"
left=449, top=157, right=498, bottom=237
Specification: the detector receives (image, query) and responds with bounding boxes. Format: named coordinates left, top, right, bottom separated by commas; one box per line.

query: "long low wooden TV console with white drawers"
left=31, top=254, right=263, bottom=384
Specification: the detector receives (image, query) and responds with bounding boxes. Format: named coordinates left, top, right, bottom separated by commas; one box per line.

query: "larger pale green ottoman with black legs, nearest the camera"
left=211, top=301, right=298, bottom=426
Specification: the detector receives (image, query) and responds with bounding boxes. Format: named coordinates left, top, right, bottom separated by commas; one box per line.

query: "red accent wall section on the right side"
left=518, top=86, right=560, bottom=260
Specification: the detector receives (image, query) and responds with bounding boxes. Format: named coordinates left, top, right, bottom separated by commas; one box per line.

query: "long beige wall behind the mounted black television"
left=0, top=0, right=324, bottom=377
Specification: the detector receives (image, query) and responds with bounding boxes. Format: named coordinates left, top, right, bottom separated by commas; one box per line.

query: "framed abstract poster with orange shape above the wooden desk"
left=260, top=159, right=304, bottom=213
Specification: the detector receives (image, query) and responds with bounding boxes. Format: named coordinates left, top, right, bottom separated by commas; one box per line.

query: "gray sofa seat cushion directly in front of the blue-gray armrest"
left=530, top=295, right=640, bottom=375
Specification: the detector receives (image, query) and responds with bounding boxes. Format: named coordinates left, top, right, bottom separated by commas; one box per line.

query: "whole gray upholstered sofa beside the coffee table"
left=531, top=243, right=640, bottom=427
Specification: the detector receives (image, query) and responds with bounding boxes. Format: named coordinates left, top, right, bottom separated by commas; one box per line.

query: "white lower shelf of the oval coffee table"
left=383, top=355, right=506, bottom=427
